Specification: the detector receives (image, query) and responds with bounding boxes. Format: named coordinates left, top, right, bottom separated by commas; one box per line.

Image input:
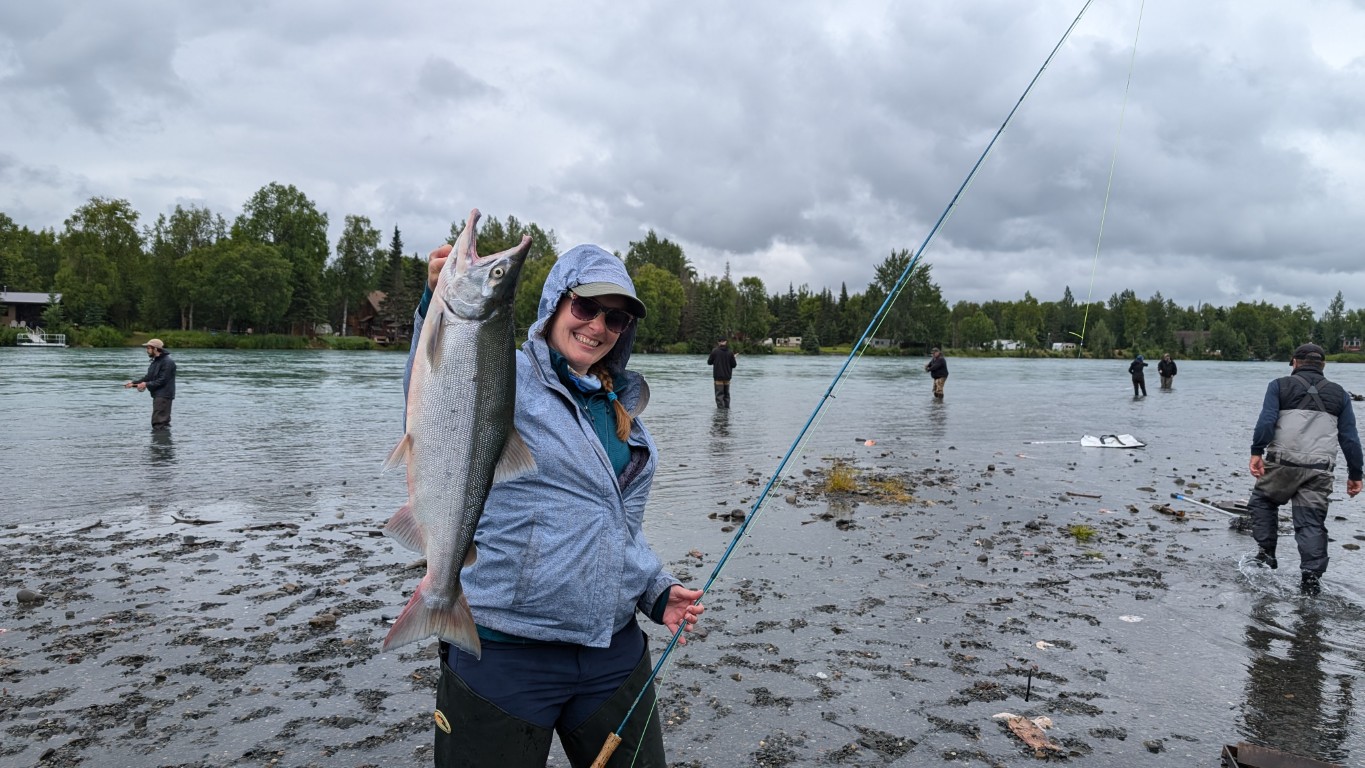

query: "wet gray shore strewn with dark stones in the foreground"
left=0, top=446, right=1361, bottom=768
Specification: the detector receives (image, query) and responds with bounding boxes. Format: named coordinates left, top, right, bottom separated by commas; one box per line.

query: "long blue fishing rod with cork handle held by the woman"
left=591, top=0, right=1095, bottom=768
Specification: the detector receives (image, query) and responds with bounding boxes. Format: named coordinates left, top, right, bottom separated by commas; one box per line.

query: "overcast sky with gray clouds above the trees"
left=0, top=0, right=1365, bottom=315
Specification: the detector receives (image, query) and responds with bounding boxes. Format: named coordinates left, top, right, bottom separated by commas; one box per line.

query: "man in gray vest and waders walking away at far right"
left=1246, top=344, right=1362, bottom=595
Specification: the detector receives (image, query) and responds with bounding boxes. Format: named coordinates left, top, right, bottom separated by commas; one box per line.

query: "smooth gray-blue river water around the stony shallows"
left=0, top=348, right=1365, bottom=765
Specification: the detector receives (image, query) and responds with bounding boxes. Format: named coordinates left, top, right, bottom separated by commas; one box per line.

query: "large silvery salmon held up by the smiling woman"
left=384, top=210, right=535, bottom=656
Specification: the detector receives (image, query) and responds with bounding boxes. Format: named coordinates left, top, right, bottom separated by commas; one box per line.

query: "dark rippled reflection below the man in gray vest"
left=1242, top=597, right=1360, bottom=764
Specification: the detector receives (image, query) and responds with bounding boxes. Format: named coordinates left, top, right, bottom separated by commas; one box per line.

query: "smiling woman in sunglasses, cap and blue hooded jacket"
left=398, top=214, right=703, bottom=768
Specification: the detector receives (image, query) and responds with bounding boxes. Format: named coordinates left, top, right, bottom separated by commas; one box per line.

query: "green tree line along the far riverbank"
left=0, top=183, right=1365, bottom=360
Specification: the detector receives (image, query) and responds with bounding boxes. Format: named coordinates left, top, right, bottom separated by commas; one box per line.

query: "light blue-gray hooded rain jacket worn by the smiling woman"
left=412, top=246, right=680, bottom=648
